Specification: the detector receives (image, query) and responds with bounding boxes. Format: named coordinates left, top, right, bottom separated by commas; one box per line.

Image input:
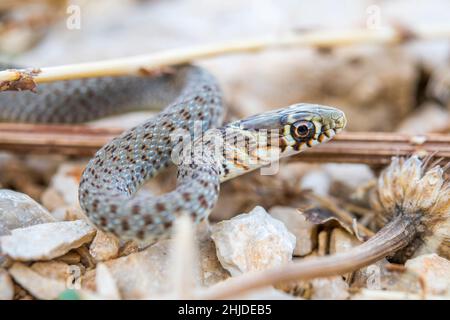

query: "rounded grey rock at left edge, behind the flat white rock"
left=0, top=189, right=55, bottom=235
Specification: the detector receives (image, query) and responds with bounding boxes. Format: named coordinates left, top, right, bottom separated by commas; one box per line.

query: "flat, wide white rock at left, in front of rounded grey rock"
left=0, top=220, right=95, bottom=261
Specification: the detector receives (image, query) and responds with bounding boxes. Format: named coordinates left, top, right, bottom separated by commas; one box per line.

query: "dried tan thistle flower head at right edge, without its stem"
left=371, top=156, right=450, bottom=262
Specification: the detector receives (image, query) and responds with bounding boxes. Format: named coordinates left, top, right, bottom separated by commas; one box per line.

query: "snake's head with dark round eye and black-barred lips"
left=236, top=103, right=347, bottom=157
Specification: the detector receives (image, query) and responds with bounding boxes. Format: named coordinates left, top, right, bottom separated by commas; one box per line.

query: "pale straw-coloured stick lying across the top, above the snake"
left=0, top=25, right=450, bottom=90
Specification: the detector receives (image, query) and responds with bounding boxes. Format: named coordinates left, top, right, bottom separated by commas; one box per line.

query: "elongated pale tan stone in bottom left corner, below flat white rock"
left=9, top=262, right=66, bottom=300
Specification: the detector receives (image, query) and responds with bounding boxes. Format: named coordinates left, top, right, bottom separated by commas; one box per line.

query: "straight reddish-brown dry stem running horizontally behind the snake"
left=0, top=123, right=450, bottom=165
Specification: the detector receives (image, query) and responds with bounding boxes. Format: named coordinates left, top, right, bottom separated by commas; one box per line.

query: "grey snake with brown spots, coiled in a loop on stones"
left=0, top=64, right=346, bottom=242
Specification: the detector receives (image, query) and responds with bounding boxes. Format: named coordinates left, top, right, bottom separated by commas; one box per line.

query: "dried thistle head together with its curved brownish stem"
left=192, top=156, right=450, bottom=298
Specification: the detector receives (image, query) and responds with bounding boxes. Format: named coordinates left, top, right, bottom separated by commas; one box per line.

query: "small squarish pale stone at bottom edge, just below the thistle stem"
left=311, top=276, right=350, bottom=300
